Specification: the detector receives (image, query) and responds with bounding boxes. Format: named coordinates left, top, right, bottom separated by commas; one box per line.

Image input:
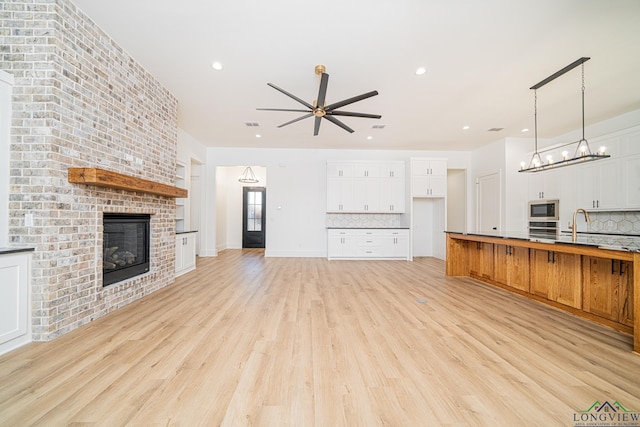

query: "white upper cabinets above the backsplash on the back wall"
left=327, top=161, right=405, bottom=213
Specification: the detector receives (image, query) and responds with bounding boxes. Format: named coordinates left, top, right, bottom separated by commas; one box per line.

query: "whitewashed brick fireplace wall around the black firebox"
left=0, top=0, right=178, bottom=340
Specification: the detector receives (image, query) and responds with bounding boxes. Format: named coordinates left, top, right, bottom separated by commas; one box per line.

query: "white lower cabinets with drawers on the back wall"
left=327, top=228, right=409, bottom=260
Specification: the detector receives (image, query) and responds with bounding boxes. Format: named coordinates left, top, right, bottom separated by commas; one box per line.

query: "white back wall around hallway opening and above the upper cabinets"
left=203, top=147, right=469, bottom=257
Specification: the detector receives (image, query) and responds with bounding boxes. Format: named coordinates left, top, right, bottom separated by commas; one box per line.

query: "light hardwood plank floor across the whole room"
left=0, top=250, right=640, bottom=427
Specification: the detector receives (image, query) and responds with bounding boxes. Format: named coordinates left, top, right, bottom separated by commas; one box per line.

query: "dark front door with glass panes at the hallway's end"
left=242, top=187, right=267, bottom=248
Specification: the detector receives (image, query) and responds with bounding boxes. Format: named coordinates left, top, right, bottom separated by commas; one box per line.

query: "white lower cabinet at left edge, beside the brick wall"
left=0, top=251, right=31, bottom=354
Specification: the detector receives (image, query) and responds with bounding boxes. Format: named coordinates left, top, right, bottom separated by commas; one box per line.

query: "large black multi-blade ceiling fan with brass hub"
left=258, top=65, right=382, bottom=136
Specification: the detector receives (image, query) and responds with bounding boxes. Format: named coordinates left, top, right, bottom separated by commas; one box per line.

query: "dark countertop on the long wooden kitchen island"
left=445, top=231, right=640, bottom=252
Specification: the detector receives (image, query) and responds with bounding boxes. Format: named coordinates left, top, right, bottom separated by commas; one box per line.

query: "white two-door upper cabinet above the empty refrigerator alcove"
left=411, top=158, right=447, bottom=197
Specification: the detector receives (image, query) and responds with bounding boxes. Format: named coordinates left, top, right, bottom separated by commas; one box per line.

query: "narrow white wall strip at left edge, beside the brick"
left=0, top=70, right=13, bottom=247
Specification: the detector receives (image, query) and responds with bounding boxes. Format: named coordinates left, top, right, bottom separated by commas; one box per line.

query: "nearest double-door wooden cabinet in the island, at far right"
left=582, top=257, right=633, bottom=326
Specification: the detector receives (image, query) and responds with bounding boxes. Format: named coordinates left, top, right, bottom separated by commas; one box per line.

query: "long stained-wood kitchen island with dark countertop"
left=446, top=232, right=640, bottom=353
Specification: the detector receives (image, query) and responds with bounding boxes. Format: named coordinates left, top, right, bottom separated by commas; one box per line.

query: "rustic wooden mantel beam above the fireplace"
left=68, top=168, right=189, bottom=198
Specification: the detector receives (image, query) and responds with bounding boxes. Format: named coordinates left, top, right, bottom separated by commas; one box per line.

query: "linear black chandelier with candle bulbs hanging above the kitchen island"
left=518, top=57, right=611, bottom=172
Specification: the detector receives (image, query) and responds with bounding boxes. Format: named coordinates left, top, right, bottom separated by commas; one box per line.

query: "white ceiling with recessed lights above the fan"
left=72, top=0, right=640, bottom=150
